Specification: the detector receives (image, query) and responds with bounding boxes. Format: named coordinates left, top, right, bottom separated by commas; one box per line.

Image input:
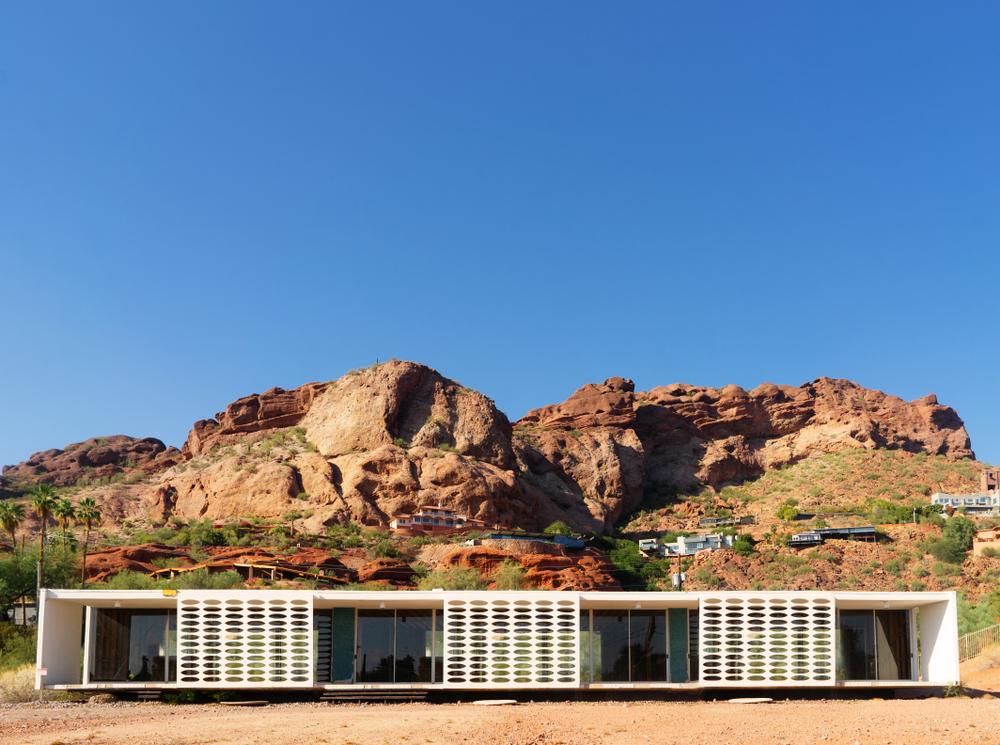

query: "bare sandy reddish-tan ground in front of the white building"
left=0, top=698, right=1000, bottom=745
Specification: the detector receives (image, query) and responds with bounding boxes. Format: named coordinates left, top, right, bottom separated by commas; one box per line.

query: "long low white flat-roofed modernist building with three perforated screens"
left=38, top=590, right=959, bottom=691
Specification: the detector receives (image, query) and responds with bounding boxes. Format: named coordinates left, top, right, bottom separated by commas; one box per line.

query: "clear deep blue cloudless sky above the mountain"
left=0, top=5, right=1000, bottom=464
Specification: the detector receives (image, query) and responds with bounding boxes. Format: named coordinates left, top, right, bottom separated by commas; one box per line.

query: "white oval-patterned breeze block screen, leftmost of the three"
left=177, top=591, right=313, bottom=688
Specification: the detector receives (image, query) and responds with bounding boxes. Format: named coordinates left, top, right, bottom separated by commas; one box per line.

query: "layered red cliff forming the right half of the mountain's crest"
left=518, top=378, right=975, bottom=500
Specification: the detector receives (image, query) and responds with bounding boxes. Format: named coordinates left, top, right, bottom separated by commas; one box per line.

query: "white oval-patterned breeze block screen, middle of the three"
left=444, top=593, right=580, bottom=688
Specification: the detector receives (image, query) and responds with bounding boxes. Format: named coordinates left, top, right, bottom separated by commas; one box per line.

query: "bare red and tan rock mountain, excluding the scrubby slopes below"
left=3, top=361, right=974, bottom=532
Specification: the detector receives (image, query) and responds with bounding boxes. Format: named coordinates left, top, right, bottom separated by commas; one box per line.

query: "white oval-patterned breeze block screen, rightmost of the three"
left=700, top=595, right=834, bottom=686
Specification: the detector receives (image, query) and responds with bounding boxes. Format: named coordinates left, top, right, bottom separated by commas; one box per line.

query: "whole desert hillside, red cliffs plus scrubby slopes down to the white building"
left=0, top=360, right=996, bottom=595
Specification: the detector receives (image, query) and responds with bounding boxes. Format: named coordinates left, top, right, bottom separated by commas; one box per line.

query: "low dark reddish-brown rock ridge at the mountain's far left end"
left=3, top=435, right=180, bottom=486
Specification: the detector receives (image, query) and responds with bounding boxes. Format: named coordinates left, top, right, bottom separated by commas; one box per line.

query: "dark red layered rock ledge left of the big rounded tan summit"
left=181, top=383, right=327, bottom=459
